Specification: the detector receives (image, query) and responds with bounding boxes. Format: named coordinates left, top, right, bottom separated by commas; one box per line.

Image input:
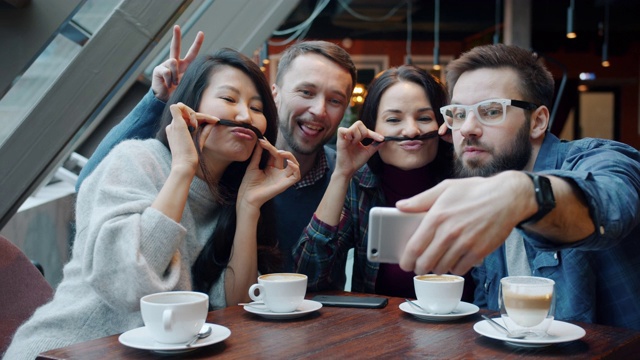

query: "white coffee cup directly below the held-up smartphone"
left=413, top=274, right=464, bottom=314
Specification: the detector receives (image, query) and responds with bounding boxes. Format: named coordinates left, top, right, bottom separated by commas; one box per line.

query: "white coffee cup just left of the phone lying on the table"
left=249, top=273, right=307, bottom=313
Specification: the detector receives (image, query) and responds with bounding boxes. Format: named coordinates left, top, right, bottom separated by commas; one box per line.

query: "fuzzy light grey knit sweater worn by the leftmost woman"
left=4, top=140, right=226, bottom=360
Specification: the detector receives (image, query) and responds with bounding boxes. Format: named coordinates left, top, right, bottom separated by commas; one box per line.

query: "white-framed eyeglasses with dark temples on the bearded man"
left=440, top=99, right=538, bottom=130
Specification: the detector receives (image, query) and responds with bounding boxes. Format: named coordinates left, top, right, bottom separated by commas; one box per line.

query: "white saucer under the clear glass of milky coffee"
left=473, top=318, right=586, bottom=347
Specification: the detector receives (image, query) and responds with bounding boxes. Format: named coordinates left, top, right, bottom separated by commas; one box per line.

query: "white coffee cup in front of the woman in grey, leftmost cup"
left=140, top=291, right=209, bottom=344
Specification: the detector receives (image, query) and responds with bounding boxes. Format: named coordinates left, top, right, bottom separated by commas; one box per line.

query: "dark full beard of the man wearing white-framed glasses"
left=454, top=121, right=532, bottom=178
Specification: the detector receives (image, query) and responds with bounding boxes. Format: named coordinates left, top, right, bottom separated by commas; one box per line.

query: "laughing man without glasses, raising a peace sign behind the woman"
left=76, top=25, right=356, bottom=272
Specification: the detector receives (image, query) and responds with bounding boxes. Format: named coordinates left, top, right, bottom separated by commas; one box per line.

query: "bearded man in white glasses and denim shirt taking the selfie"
left=397, top=44, right=640, bottom=330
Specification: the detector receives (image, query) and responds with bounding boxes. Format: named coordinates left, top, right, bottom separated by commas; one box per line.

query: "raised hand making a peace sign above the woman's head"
left=151, top=25, right=204, bottom=102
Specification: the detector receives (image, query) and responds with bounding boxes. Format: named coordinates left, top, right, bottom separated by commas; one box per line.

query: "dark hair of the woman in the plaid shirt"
left=360, top=65, right=453, bottom=179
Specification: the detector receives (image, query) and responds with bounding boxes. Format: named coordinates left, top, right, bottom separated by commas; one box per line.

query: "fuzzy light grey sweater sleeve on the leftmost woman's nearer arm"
left=73, top=140, right=191, bottom=309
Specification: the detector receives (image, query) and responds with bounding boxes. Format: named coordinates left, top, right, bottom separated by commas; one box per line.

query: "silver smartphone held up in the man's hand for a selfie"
left=367, top=207, right=426, bottom=264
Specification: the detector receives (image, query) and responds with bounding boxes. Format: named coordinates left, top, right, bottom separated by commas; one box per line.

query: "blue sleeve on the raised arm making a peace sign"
left=76, top=90, right=166, bottom=192
